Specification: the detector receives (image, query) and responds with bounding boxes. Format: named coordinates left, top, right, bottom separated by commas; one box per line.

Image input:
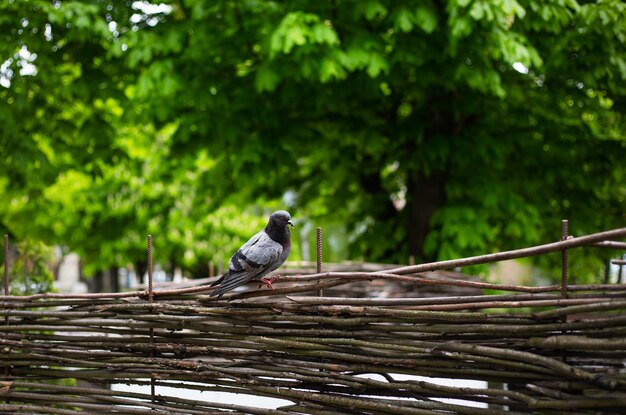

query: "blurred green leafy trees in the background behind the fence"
left=0, top=0, right=626, bottom=292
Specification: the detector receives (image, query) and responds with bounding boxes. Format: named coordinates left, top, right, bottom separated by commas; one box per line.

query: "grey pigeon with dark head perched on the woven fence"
left=211, top=210, right=294, bottom=300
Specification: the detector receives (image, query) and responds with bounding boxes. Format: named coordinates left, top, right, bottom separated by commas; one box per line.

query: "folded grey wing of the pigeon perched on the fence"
left=213, top=231, right=283, bottom=295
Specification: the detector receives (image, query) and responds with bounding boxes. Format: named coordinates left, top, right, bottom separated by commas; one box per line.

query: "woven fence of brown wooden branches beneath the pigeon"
left=0, top=229, right=626, bottom=414
